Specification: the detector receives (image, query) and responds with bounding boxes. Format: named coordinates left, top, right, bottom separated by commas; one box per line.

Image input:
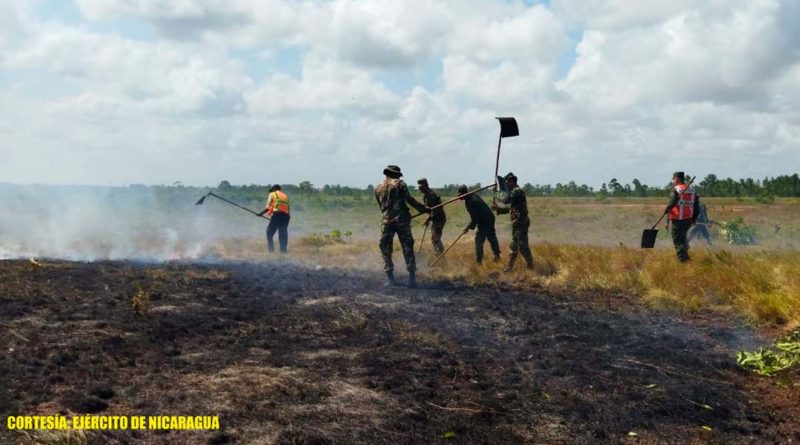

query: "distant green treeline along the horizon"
left=167, top=173, right=800, bottom=200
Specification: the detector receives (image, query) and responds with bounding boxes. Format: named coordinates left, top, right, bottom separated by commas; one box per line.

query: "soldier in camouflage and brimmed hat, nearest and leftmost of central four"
left=375, top=165, right=430, bottom=287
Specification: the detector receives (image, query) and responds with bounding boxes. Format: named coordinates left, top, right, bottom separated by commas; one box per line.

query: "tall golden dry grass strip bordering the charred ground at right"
left=424, top=244, right=800, bottom=327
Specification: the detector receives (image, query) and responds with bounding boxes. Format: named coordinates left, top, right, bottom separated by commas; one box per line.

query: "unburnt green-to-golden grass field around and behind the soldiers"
left=194, top=198, right=800, bottom=329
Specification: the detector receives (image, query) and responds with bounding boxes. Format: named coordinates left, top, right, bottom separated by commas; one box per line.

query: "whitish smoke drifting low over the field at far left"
left=0, top=184, right=264, bottom=261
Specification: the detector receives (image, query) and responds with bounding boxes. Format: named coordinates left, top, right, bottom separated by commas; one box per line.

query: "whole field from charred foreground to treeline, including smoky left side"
left=0, top=196, right=800, bottom=445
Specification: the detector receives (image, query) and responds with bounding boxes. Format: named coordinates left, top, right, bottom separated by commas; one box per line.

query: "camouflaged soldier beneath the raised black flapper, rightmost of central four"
left=492, top=173, right=533, bottom=272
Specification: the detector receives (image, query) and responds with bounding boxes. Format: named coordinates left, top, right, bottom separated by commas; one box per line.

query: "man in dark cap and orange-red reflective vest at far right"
left=664, top=172, right=700, bottom=263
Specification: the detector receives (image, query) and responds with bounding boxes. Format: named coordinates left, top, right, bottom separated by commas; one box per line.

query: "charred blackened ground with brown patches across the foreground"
left=0, top=261, right=800, bottom=444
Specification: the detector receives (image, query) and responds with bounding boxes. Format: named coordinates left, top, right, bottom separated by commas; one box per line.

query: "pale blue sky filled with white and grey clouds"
left=0, top=0, right=800, bottom=186
